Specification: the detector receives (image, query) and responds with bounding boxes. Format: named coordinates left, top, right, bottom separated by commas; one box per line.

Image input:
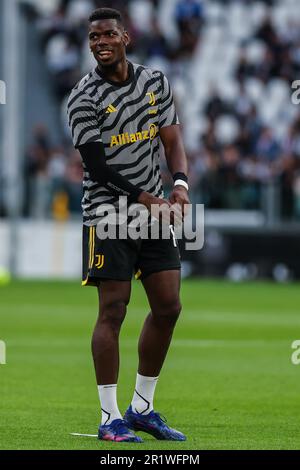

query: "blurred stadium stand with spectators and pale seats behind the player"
left=10, top=0, right=300, bottom=220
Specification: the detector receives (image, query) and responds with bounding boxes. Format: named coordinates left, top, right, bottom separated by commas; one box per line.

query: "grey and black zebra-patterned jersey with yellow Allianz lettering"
left=68, top=62, right=179, bottom=226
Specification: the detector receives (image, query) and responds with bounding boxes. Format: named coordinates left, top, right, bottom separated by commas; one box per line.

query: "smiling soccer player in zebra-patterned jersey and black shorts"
left=68, top=8, right=189, bottom=442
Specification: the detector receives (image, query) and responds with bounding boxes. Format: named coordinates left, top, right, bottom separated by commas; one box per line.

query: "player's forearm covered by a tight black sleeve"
left=78, top=142, right=143, bottom=202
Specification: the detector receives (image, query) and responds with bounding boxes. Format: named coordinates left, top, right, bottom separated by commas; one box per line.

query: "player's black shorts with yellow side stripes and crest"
left=82, top=225, right=180, bottom=286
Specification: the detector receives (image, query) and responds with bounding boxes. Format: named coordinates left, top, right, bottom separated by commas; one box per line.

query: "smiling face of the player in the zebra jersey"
left=89, top=19, right=129, bottom=67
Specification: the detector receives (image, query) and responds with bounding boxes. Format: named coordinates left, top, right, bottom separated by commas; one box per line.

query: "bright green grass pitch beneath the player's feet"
left=0, top=279, right=300, bottom=450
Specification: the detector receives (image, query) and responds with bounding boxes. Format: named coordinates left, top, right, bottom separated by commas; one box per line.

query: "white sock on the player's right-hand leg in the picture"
left=131, top=374, right=158, bottom=415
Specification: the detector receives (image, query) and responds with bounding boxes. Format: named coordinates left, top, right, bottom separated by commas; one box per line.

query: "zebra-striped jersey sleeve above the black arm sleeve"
left=67, top=91, right=101, bottom=148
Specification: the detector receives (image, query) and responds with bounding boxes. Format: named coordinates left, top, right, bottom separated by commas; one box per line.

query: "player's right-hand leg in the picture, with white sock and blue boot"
left=124, top=270, right=186, bottom=441
